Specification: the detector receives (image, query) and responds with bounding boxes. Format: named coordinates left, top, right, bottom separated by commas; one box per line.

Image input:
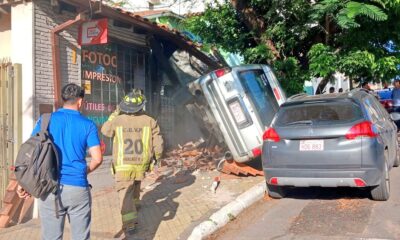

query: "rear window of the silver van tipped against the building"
left=238, top=70, right=279, bottom=126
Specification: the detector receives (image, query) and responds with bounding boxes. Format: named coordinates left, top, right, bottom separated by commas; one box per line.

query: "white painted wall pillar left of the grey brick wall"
left=11, top=2, right=35, bottom=141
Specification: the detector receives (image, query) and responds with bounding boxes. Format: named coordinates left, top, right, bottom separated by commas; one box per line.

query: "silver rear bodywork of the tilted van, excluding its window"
left=199, top=65, right=286, bottom=162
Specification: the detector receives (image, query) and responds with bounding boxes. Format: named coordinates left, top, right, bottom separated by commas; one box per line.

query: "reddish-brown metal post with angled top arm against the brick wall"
left=50, top=13, right=85, bottom=109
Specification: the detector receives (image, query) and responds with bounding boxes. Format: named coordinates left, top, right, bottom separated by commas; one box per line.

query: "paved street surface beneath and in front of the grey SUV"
left=210, top=168, right=400, bottom=240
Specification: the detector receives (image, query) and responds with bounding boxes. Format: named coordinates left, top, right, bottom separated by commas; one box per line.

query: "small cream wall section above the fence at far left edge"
left=0, top=14, right=11, bottom=60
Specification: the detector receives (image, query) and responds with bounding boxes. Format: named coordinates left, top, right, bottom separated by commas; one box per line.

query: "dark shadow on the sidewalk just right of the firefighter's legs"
left=128, top=171, right=196, bottom=239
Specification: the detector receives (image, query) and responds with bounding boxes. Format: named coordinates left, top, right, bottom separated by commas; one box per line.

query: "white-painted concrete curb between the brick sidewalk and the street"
left=188, top=181, right=266, bottom=240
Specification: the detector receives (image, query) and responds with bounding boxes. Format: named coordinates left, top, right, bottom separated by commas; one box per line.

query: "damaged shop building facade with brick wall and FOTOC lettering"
left=0, top=0, right=220, bottom=206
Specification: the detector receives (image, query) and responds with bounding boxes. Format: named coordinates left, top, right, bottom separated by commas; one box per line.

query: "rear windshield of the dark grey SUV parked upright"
left=275, top=101, right=363, bottom=126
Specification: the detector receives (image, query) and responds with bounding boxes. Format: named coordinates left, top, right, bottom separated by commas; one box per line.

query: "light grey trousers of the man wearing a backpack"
left=39, top=185, right=92, bottom=240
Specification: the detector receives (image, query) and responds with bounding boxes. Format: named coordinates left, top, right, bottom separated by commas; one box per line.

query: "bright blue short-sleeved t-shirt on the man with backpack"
left=32, top=108, right=100, bottom=187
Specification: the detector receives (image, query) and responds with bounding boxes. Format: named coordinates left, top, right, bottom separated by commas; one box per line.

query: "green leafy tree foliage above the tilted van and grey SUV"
left=186, top=0, right=400, bottom=94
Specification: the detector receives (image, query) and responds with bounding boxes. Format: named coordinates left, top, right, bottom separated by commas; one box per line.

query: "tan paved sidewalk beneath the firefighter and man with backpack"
left=0, top=158, right=264, bottom=240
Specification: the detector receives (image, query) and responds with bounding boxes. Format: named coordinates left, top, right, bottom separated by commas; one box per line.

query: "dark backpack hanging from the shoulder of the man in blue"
left=14, top=113, right=60, bottom=199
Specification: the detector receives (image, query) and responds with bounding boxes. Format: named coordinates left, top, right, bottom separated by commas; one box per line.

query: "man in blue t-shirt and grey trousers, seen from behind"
left=18, top=84, right=103, bottom=240
